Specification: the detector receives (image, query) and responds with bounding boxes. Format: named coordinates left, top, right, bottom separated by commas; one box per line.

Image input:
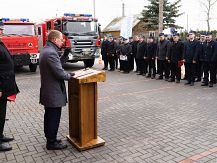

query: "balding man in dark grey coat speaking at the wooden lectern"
left=39, top=30, right=74, bottom=150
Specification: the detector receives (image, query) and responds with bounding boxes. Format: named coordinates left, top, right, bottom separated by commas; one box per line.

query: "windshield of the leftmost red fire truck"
left=4, top=24, right=35, bottom=36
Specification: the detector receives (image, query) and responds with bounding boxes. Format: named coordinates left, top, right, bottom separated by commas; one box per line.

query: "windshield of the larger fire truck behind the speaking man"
left=63, top=21, right=97, bottom=35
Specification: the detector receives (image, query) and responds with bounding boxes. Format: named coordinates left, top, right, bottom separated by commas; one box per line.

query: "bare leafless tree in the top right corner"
left=200, top=0, right=217, bottom=31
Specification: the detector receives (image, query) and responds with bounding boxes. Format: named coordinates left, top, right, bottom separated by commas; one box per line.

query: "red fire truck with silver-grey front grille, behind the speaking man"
left=37, top=13, right=101, bottom=67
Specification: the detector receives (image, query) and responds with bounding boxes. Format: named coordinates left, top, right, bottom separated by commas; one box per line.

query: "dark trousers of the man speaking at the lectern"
left=44, top=107, right=62, bottom=143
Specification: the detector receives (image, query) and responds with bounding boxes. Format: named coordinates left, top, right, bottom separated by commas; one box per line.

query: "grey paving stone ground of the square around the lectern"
left=0, top=61, right=217, bottom=163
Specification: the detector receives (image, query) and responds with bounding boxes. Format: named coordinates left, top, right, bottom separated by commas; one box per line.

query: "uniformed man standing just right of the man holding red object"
left=183, top=31, right=199, bottom=86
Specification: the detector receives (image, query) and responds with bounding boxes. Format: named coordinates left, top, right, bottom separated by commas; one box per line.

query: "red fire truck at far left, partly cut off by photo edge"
left=0, top=18, right=39, bottom=72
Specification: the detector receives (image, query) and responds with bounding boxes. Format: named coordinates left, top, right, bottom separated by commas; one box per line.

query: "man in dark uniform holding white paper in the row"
left=120, top=38, right=132, bottom=73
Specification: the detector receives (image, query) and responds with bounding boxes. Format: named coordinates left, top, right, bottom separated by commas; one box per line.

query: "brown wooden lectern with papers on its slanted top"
left=67, top=69, right=105, bottom=151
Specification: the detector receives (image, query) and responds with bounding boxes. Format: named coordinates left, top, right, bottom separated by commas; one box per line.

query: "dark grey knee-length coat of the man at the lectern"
left=39, top=41, right=71, bottom=107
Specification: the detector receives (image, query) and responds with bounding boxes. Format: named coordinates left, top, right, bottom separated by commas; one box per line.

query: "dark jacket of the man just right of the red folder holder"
left=183, top=40, right=199, bottom=63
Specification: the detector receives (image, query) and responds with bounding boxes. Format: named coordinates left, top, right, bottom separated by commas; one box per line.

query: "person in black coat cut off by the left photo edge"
left=0, top=26, right=19, bottom=151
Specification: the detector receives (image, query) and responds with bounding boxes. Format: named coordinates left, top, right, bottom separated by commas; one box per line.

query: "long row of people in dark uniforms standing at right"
left=101, top=31, right=217, bottom=87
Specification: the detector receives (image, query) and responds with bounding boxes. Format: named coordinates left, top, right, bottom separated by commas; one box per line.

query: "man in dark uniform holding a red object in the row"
left=168, top=33, right=184, bottom=83
